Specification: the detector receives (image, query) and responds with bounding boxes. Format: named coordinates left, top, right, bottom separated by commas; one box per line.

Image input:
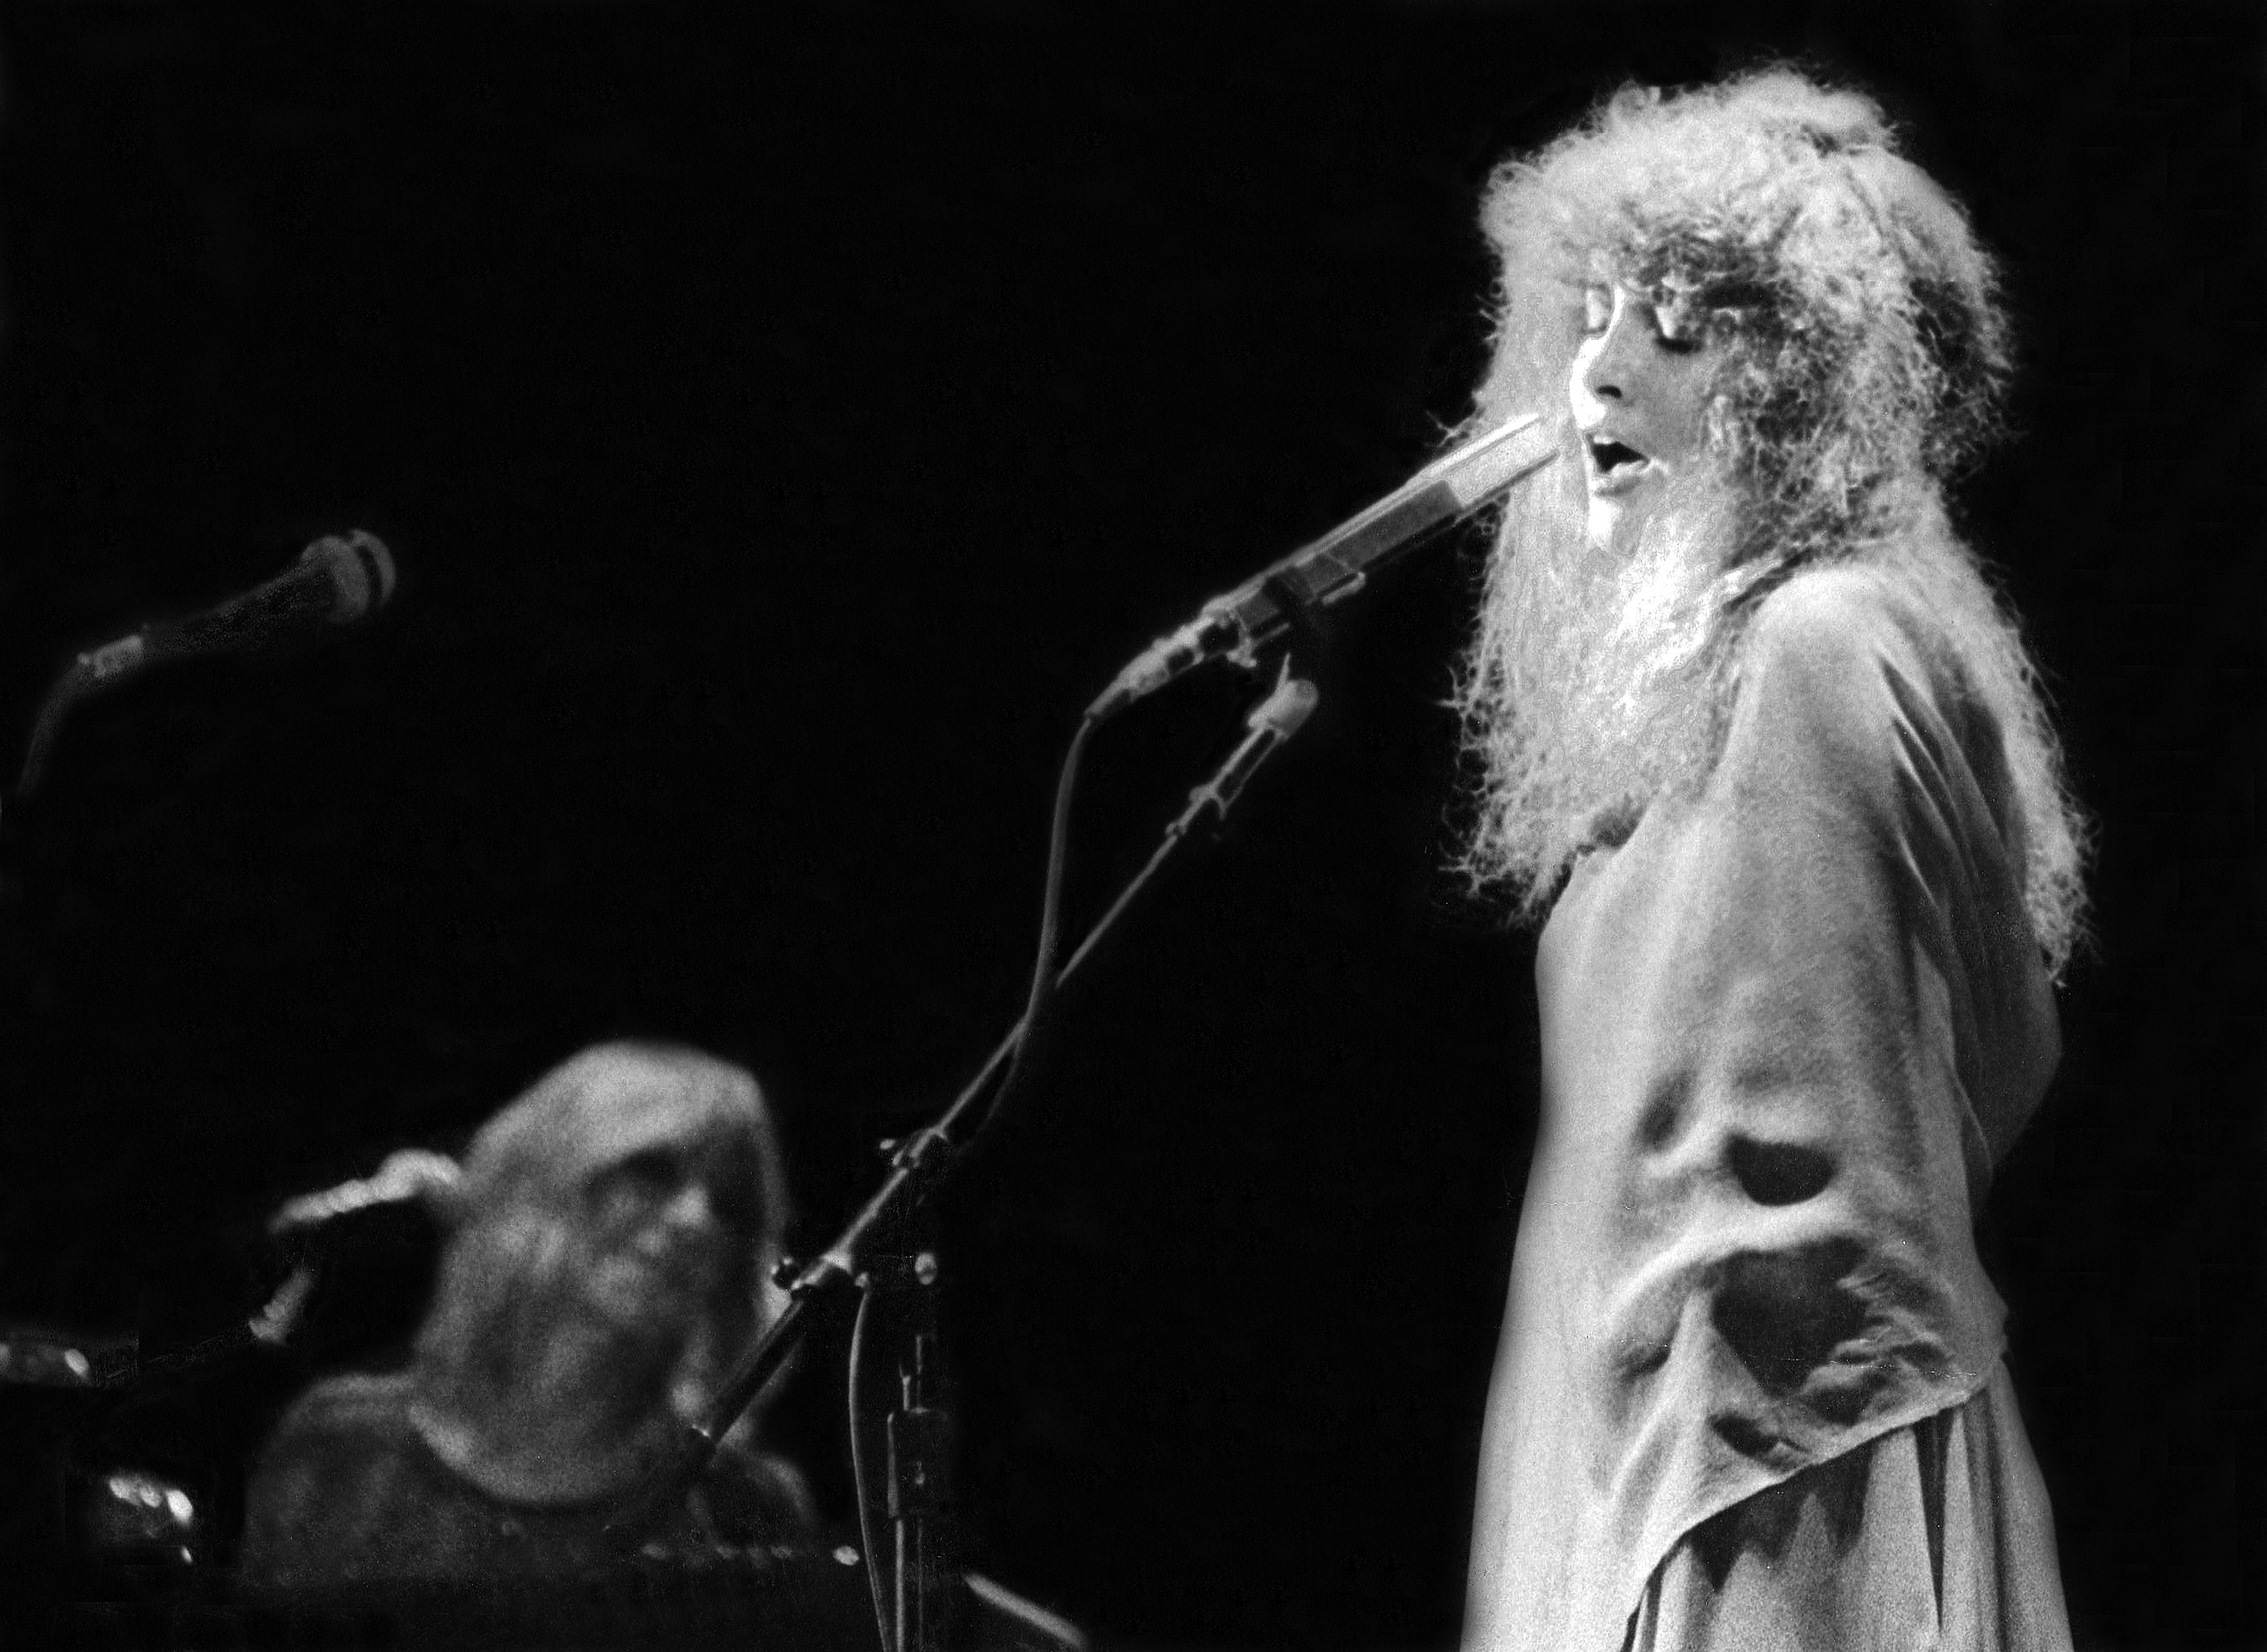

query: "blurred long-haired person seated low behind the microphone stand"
left=240, top=1042, right=814, bottom=1589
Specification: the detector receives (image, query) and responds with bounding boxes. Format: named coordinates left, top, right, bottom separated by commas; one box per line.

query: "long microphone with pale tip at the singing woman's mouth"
left=1088, top=413, right=1560, bottom=719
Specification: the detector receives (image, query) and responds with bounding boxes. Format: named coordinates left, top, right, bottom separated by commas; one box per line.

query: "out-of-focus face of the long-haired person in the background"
left=583, top=1146, right=755, bottom=1330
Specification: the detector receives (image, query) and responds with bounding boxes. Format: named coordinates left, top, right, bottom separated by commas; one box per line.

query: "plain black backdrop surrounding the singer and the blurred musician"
left=0, top=0, right=2267, bottom=1647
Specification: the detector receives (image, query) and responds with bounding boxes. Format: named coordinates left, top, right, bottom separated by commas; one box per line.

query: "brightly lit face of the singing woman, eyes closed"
left=1566, top=281, right=1721, bottom=549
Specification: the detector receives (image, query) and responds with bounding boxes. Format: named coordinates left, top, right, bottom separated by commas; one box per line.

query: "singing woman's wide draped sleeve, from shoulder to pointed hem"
left=1573, top=569, right=2056, bottom=1552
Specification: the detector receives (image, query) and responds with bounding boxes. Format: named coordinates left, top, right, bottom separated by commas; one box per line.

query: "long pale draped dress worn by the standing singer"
left=1464, top=567, right=2070, bottom=1652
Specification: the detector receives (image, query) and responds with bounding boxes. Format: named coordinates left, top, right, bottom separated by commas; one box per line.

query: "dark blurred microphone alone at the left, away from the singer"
left=16, top=528, right=394, bottom=800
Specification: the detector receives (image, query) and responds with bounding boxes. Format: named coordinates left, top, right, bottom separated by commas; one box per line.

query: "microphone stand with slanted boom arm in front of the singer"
left=605, top=664, right=1317, bottom=1652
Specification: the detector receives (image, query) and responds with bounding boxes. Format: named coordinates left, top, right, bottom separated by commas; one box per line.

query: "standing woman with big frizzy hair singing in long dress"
left=1460, top=70, right=2083, bottom=1652
